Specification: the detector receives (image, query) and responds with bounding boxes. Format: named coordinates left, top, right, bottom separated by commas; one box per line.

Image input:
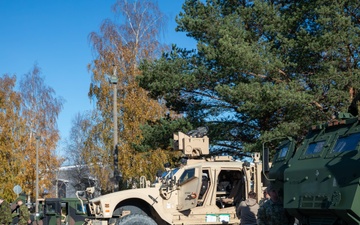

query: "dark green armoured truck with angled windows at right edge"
left=264, top=113, right=360, bottom=225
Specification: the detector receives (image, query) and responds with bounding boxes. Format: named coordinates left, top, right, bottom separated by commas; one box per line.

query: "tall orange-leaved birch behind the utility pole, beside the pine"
left=87, top=0, right=172, bottom=190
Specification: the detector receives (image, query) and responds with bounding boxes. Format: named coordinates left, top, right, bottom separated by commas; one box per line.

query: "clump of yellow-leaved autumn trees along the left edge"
left=0, top=66, right=62, bottom=202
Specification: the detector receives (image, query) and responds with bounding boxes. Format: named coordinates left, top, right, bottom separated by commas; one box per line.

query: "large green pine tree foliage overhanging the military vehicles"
left=139, top=0, right=360, bottom=152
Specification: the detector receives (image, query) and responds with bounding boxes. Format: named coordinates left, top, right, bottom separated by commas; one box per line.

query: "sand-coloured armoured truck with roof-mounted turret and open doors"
left=86, top=132, right=262, bottom=225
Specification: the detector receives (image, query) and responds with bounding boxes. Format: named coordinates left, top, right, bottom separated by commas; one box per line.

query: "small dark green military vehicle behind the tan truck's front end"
left=32, top=193, right=87, bottom=225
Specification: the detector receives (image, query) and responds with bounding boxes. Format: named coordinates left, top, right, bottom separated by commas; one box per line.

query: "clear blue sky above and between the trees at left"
left=0, top=0, right=195, bottom=153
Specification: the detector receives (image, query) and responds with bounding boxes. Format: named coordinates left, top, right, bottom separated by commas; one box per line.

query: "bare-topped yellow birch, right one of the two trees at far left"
left=19, top=65, right=63, bottom=197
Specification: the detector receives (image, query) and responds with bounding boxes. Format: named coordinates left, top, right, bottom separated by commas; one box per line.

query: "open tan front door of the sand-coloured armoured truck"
left=177, top=167, right=201, bottom=211
